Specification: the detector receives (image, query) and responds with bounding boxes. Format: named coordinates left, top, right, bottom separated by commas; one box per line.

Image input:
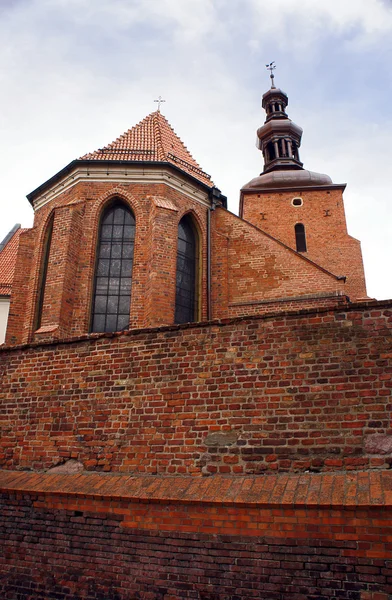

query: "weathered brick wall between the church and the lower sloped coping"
left=0, top=302, right=392, bottom=475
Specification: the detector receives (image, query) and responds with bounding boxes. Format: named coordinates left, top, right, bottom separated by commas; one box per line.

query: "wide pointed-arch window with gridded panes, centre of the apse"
left=91, top=200, right=135, bottom=332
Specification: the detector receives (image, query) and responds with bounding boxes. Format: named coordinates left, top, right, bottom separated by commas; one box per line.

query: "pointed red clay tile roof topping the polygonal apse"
left=81, top=111, right=214, bottom=187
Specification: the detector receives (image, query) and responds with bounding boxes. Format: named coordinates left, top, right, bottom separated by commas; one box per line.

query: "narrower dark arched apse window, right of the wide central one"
left=175, top=215, right=199, bottom=323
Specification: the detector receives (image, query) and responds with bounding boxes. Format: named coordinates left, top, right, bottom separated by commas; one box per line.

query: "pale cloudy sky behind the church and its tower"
left=0, top=0, right=392, bottom=299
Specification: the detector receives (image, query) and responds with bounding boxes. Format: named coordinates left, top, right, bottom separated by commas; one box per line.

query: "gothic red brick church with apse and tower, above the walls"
left=7, top=74, right=366, bottom=344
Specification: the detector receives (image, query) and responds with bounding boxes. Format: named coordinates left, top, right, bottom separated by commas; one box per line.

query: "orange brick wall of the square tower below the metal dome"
left=242, top=189, right=366, bottom=301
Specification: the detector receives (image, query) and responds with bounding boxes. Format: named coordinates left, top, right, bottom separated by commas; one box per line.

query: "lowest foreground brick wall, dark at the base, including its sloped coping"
left=0, top=472, right=392, bottom=600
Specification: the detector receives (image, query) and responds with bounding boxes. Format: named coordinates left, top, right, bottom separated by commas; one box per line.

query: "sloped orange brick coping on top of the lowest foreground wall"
left=0, top=470, right=392, bottom=509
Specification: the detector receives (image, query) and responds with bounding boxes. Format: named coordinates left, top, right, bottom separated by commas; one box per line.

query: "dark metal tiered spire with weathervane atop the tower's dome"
left=257, top=62, right=303, bottom=173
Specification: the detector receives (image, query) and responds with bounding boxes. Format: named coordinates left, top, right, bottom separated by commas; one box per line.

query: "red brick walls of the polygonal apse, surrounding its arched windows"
left=7, top=182, right=207, bottom=344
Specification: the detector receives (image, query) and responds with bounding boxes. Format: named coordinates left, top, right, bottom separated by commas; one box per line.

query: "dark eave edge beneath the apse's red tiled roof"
left=26, top=159, right=215, bottom=205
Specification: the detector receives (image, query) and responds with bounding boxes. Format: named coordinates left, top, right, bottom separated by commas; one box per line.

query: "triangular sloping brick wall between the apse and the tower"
left=212, top=209, right=345, bottom=318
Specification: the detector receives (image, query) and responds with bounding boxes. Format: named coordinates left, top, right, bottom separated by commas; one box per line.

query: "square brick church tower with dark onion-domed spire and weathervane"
left=240, top=66, right=367, bottom=301
